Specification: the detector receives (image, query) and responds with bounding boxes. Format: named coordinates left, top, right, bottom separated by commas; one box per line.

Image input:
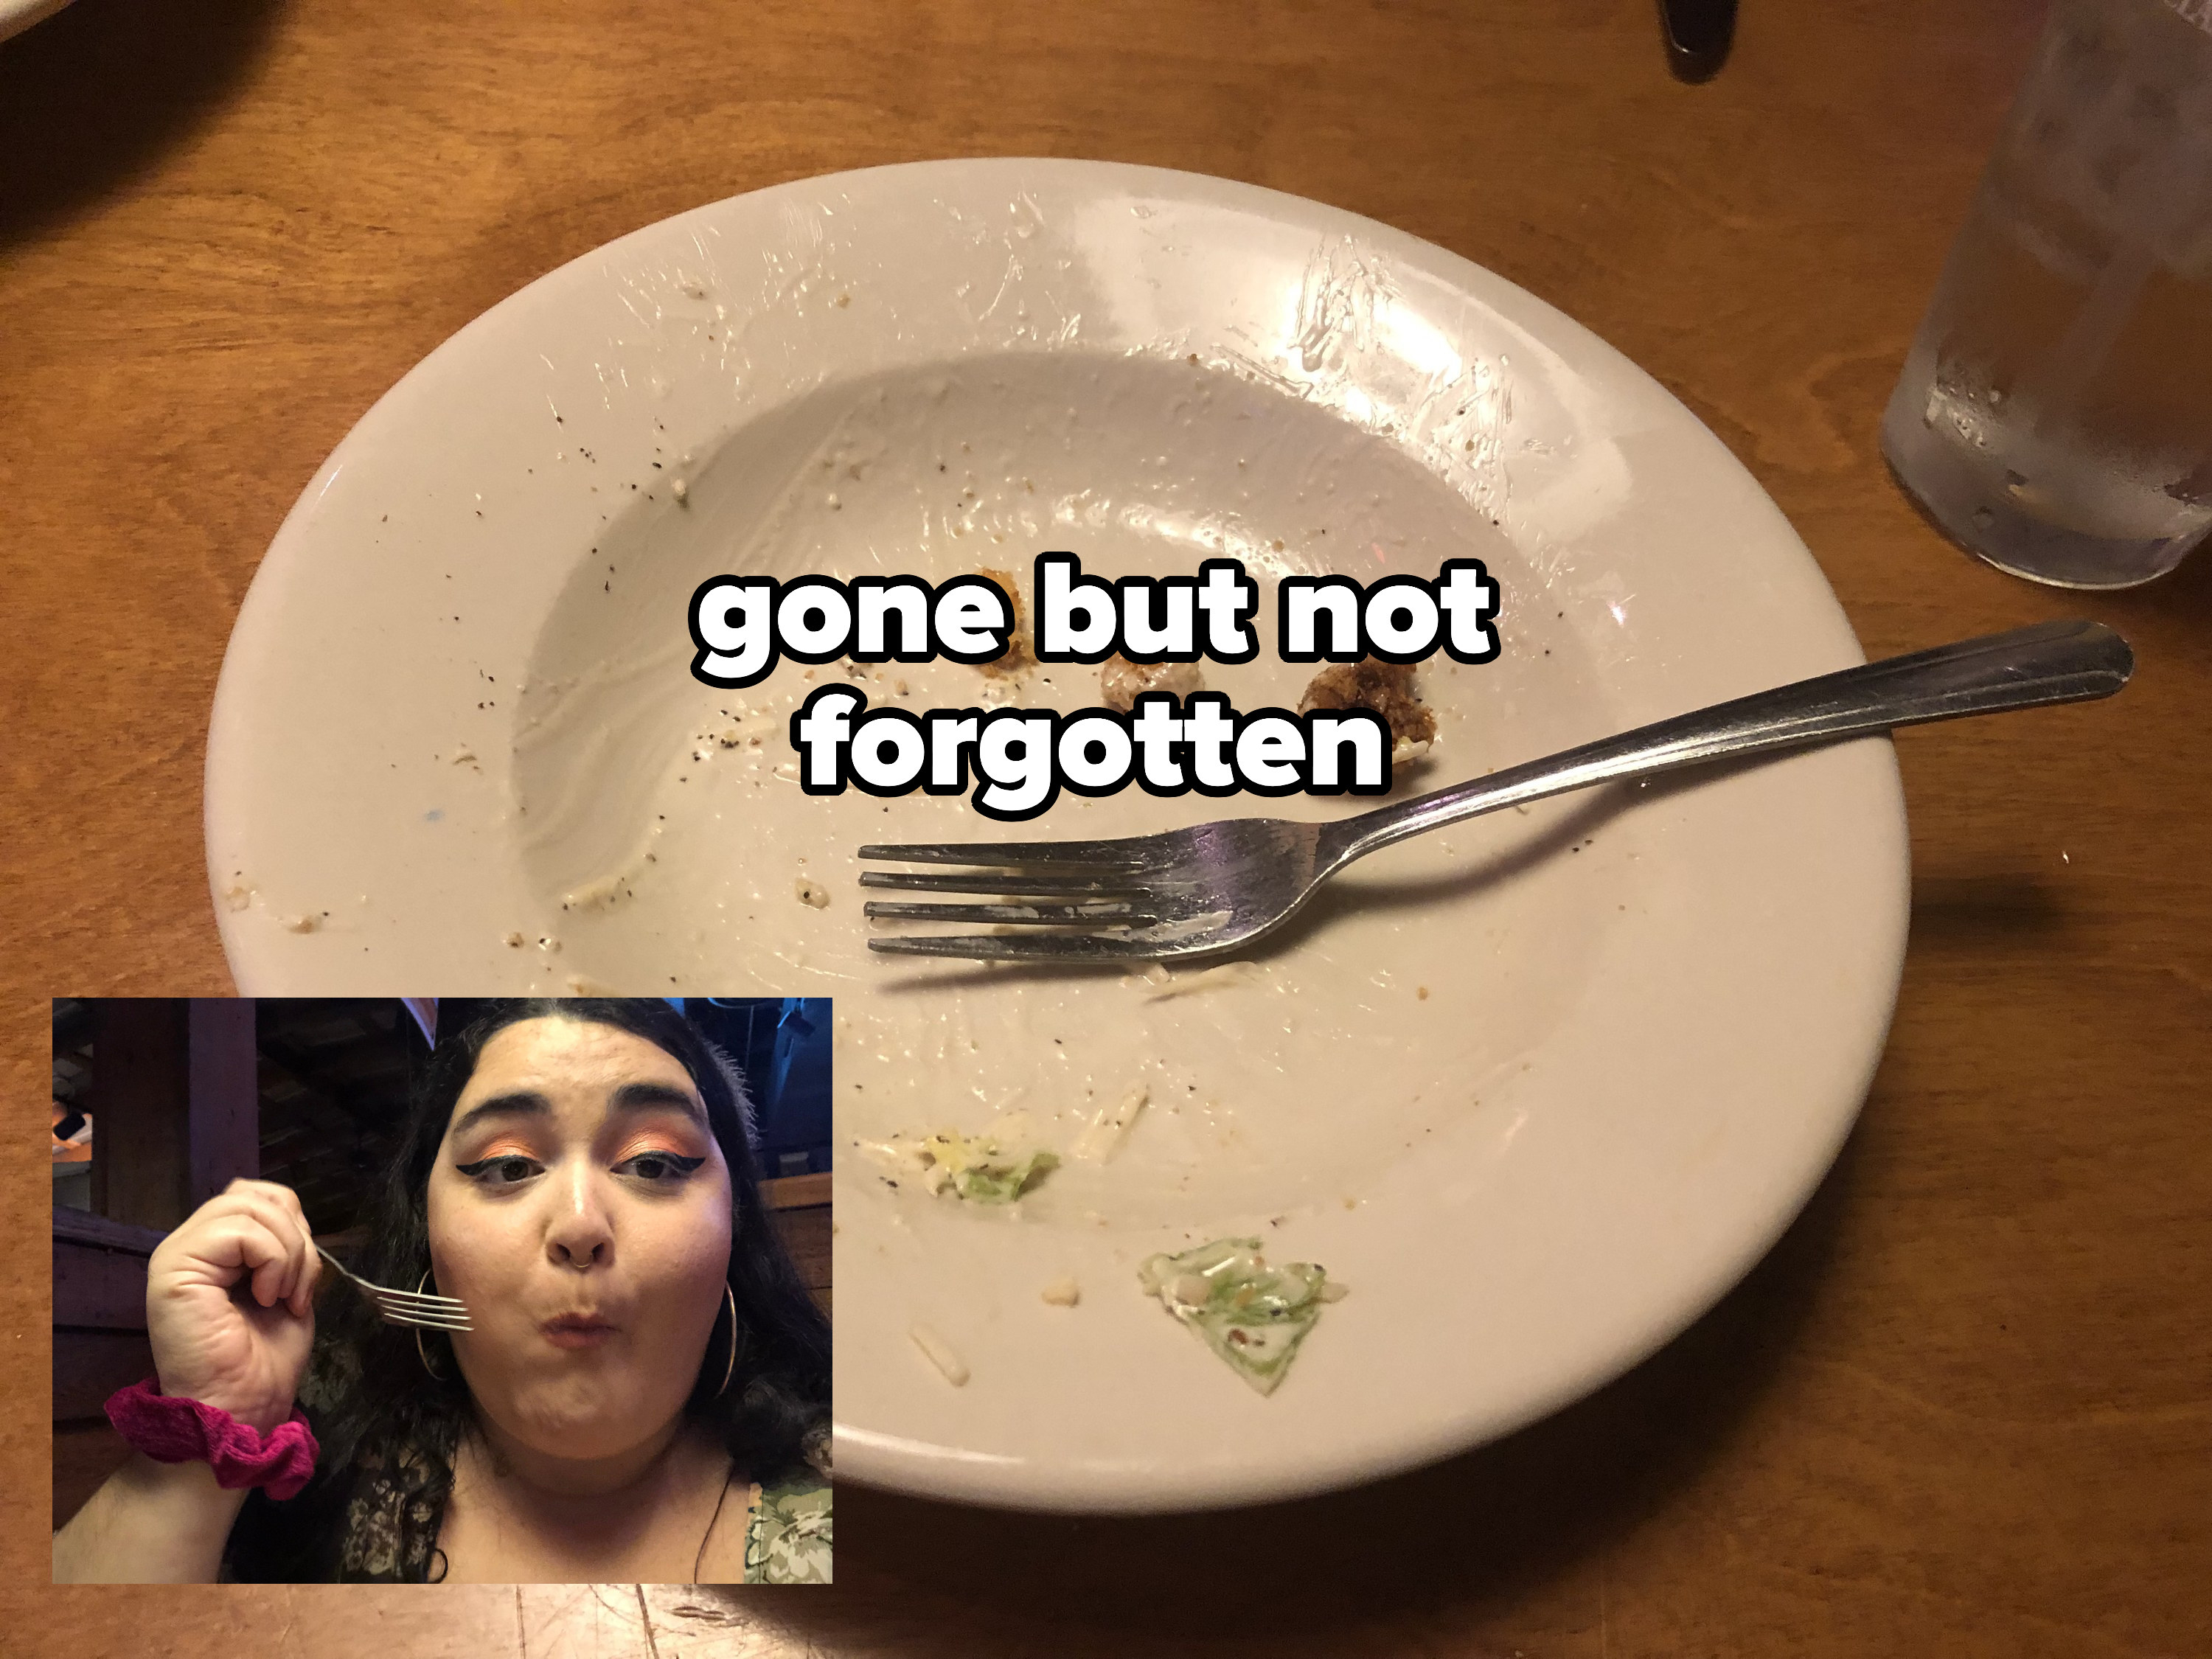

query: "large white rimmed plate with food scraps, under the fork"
left=208, top=161, right=1907, bottom=1509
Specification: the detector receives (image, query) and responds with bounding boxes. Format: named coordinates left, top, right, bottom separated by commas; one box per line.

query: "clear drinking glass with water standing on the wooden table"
left=1882, top=0, right=2212, bottom=588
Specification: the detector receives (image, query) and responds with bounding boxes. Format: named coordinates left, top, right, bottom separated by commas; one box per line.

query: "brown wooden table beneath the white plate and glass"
left=0, top=0, right=2212, bottom=1659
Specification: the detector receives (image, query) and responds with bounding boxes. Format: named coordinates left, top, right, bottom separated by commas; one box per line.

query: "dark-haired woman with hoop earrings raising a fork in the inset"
left=53, top=1000, right=830, bottom=1584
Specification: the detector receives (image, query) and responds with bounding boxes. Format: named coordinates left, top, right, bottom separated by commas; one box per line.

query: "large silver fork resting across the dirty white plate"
left=860, top=622, right=2135, bottom=962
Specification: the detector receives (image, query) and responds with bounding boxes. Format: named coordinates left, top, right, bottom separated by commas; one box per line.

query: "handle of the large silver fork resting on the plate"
left=1325, top=622, right=2135, bottom=869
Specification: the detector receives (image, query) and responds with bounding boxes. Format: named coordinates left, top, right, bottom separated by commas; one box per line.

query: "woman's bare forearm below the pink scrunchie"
left=53, top=1451, right=246, bottom=1584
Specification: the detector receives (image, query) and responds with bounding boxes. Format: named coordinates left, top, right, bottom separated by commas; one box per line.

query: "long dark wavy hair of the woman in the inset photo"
left=228, top=998, right=830, bottom=1584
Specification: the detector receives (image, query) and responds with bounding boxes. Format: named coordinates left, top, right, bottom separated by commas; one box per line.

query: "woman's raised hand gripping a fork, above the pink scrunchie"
left=146, top=1181, right=323, bottom=1433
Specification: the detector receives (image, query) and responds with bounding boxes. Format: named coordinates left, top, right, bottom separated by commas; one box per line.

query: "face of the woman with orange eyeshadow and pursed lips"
left=429, top=1020, right=730, bottom=1458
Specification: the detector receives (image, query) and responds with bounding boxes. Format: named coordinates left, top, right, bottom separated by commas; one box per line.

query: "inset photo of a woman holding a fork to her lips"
left=53, top=998, right=832, bottom=1584
